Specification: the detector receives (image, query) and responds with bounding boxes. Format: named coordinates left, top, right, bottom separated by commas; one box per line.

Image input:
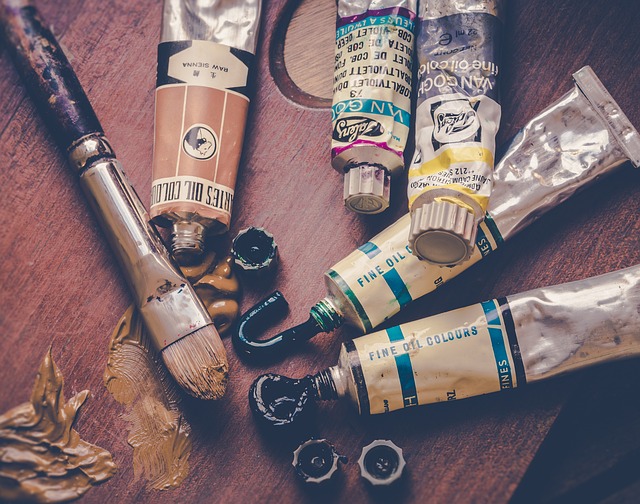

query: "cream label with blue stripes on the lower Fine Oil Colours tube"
left=353, top=300, right=524, bottom=414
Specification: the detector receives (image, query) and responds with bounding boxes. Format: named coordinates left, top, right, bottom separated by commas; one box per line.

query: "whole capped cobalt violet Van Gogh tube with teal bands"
left=331, top=0, right=417, bottom=214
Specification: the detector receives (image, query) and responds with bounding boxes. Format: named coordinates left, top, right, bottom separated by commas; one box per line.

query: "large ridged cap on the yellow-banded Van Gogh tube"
left=409, top=201, right=478, bottom=266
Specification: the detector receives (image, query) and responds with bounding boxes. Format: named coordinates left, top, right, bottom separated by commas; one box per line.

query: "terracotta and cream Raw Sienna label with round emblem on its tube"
left=150, top=40, right=253, bottom=228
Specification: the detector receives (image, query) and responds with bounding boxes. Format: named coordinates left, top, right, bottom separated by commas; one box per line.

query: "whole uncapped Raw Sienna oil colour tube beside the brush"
left=150, top=0, right=262, bottom=263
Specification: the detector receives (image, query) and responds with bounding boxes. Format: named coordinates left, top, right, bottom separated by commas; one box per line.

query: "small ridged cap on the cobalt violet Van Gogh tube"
left=344, top=164, right=391, bottom=214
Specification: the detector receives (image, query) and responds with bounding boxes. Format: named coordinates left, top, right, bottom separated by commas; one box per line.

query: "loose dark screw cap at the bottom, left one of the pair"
left=292, top=439, right=347, bottom=483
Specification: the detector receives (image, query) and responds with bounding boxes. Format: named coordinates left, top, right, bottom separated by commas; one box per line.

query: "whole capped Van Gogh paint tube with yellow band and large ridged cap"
left=408, top=0, right=506, bottom=265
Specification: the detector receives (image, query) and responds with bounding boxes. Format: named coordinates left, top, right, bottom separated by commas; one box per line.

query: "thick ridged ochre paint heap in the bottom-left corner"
left=0, top=348, right=116, bottom=502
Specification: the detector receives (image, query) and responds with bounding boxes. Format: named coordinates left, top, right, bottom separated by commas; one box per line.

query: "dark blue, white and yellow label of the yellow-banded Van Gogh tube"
left=408, top=13, right=501, bottom=216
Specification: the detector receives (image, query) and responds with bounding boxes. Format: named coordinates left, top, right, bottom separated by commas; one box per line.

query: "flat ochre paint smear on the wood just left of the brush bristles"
left=104, top=305, right=191, bottom=490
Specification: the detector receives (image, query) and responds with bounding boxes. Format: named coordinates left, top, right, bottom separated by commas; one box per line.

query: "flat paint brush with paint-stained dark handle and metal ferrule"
left=0, top=0, right=228, bottom=399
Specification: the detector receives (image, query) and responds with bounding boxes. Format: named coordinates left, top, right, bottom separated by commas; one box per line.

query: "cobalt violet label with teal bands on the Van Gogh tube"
left=331, top=7, right=415, bottom=170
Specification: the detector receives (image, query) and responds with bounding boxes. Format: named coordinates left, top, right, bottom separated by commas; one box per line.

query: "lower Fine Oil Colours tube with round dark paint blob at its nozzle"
left=250, top=266, right=640, bottom=425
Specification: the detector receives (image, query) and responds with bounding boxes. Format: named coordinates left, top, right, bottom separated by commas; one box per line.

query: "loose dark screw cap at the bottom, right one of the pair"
left=358, top=439, right=406, bottom=486
